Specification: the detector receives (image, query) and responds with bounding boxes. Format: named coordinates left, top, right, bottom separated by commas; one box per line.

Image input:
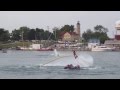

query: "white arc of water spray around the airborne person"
left=45, top=49, right=93, bottom=67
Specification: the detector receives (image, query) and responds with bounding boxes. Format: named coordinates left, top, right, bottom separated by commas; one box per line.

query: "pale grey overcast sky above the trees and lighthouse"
left=0, top=11, right=120, bottom=38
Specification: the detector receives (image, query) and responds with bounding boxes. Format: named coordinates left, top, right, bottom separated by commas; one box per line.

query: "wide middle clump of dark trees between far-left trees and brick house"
left=11, top=26, right=54, bottom=41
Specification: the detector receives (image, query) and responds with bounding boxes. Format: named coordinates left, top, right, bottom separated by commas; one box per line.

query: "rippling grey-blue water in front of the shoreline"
left=0, top=51, right=120, bottom=79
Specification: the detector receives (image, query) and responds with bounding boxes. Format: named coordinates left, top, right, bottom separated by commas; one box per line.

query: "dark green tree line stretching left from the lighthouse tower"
left=0, top=25, right=74, bottom=42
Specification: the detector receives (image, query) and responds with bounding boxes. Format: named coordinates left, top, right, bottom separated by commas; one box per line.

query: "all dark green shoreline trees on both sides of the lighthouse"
left=0, top=25, right=109, bottom=43
